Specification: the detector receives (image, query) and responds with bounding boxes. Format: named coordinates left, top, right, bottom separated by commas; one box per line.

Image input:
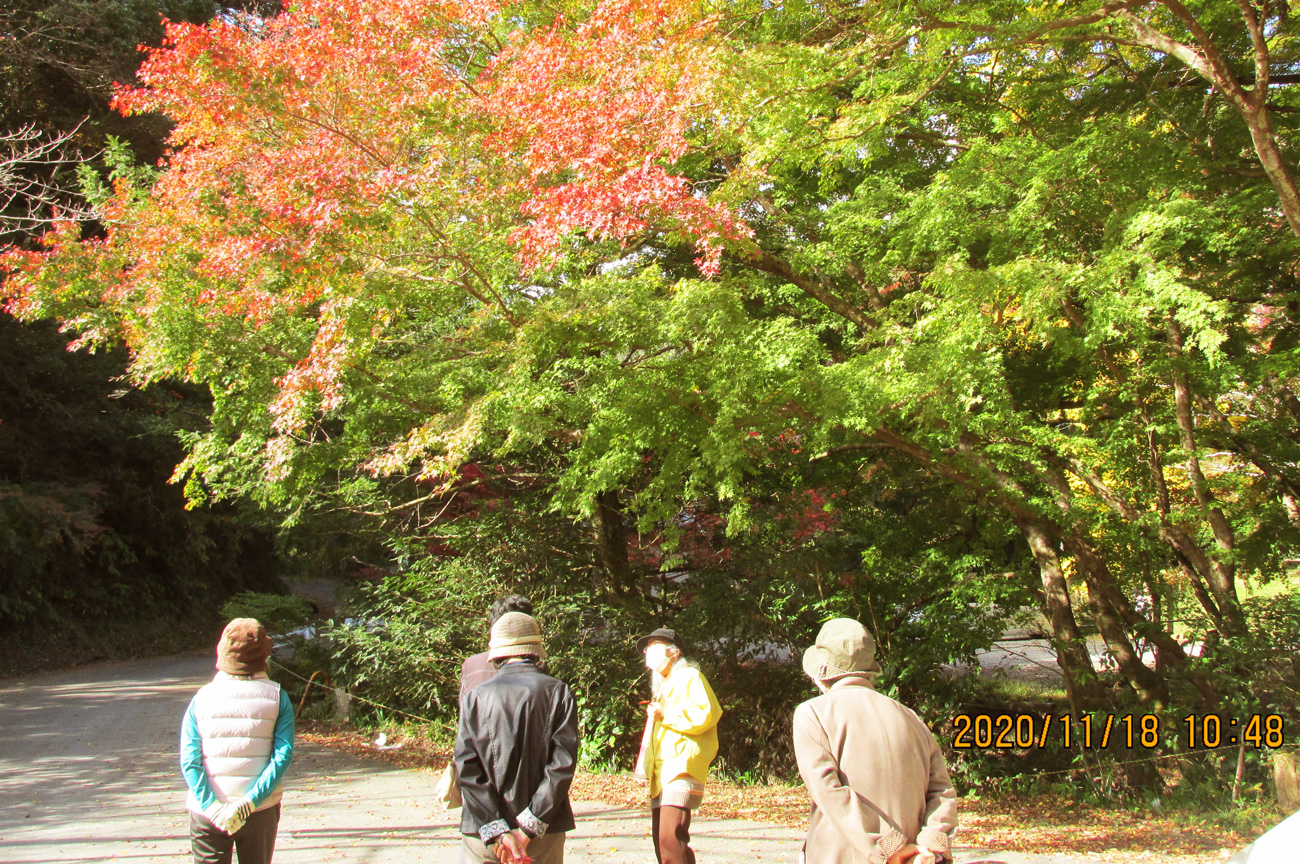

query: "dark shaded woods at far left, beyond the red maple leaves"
left=0, top=0, right=286, bottom=673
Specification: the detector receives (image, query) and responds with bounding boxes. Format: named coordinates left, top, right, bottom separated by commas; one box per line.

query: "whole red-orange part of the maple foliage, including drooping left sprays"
left=3, top=0, right=748, bottom=470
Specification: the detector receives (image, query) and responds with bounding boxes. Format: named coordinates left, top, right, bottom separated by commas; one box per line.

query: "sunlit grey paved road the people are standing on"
left=0, top=654, right=1118, bottom=864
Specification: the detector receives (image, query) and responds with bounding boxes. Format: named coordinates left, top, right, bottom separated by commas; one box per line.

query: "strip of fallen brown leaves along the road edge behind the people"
left=299, top=724, right=1253, bottom=864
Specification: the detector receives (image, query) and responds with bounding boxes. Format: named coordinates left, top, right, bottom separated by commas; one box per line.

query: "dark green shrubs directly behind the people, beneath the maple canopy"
left=332, top=513, right=1000, bottom=780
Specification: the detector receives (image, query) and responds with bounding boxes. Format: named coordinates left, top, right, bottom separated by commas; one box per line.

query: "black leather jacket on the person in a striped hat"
left=455, top=660, right=577, bottom=843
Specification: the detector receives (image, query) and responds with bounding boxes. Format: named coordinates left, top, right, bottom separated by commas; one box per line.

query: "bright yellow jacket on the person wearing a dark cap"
left=646, top=660, right=723, bottom=798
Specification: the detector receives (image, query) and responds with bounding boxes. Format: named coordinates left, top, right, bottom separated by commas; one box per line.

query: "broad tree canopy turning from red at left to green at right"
left=5, top=0, right=1300, bottom=763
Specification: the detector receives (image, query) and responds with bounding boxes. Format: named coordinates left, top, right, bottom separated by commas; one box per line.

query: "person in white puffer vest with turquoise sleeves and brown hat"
left=181, top=618, right=294, bottom=864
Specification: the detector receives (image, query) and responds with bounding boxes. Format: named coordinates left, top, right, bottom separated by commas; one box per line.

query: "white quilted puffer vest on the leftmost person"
left=187, top=672, right=282, bottom=812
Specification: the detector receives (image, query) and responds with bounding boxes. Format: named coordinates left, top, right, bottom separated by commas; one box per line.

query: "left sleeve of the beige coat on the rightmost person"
left=794, top=703, right=907, bottom=860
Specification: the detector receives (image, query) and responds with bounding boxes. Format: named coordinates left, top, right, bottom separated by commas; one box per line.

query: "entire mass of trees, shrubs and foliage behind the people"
left=0, top=0, right=1300, bottom=794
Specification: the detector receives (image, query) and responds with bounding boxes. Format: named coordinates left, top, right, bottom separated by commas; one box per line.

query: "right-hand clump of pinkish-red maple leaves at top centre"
left=489, top=0, right=748, bottom=273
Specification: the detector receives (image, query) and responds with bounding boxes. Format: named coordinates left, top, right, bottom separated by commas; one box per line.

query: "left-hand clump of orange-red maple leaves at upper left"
left=104, top=0, right=497, bottom=327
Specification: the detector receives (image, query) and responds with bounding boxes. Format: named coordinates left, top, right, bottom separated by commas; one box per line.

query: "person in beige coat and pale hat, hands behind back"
left=794, top=618, right=957, bottom=864
